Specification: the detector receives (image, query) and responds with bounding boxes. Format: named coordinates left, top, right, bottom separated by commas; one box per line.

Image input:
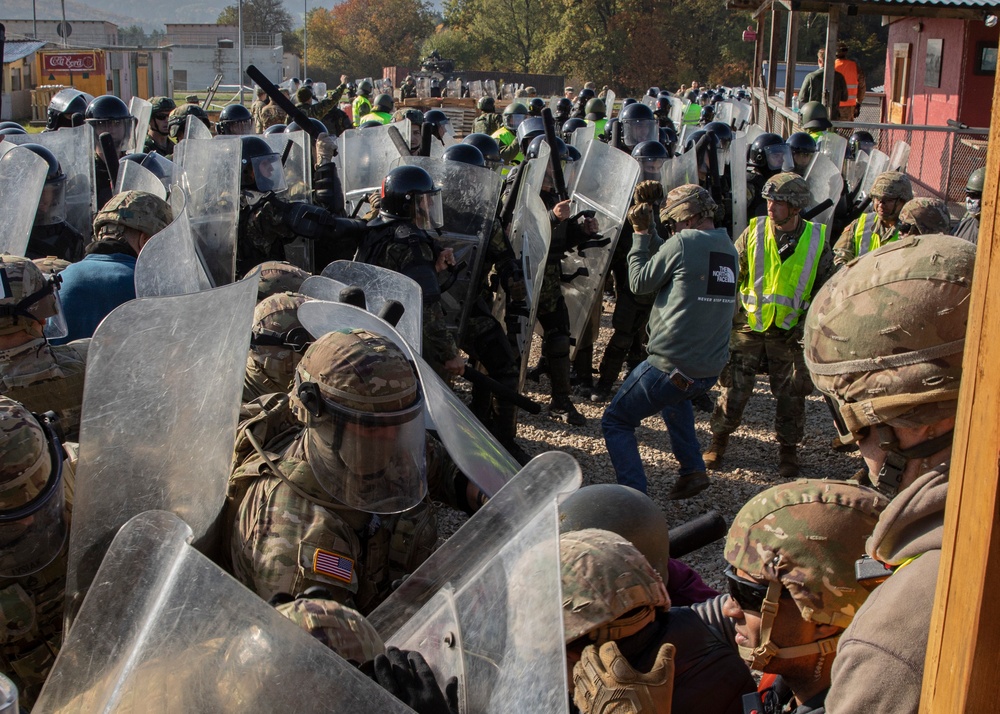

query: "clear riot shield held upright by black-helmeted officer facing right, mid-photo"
left=403, top=156, right=503, bottom=343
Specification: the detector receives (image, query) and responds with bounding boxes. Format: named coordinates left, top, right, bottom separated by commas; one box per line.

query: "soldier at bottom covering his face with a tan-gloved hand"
left=559, top=528, right=754, bottom=714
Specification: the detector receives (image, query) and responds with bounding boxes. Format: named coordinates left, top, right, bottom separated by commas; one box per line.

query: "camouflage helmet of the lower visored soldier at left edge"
left=0, top=396, right=51, bottom=509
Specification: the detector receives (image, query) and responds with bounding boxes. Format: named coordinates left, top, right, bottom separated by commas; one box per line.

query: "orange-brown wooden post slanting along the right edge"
left=920, top=47, right=1000, bottom=714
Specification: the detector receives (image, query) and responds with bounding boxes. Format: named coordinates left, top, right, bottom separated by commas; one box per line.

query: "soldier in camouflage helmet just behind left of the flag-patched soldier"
left=243, top=293, right=313, bottom=402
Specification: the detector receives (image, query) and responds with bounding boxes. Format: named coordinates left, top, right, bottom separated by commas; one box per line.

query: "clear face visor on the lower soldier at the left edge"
left=0, top=430, right=68, bottom=578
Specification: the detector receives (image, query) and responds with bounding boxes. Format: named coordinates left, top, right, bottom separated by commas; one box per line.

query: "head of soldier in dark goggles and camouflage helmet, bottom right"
left=722, top=479, right=888, bottom=714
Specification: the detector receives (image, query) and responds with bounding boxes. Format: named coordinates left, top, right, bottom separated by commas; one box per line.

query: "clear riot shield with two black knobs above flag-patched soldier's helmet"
left=320, top=260, right=424, bottom=352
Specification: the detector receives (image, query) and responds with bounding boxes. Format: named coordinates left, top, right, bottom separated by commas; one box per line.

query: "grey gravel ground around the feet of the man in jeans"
left=439, top=300, right=863, bottom=589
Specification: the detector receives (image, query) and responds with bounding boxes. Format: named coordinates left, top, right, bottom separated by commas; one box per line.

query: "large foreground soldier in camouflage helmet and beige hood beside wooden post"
left=804, top=235, right=976, bottom=714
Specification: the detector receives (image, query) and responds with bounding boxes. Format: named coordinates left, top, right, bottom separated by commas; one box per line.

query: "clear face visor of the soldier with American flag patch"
left=296, top=379, right=427, bottom=514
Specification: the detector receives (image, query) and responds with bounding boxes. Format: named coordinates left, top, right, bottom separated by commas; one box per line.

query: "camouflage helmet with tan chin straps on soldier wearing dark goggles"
left=725, top=479, right=888, bottom=670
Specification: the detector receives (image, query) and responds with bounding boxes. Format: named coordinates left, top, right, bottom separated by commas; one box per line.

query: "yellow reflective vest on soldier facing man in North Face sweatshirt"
left=740, top=218, right=826, bottom=332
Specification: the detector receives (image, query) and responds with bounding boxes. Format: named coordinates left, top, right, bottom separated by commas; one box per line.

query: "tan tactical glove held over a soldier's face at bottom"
left=573, top=642, right=675, bottom=714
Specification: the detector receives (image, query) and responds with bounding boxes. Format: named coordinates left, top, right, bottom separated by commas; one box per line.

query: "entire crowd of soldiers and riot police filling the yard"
left=0, top=73, right=985, bottom=714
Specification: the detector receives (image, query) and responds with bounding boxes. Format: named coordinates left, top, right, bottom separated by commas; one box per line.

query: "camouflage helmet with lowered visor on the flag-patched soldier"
left=290, top=330, right=427, bottom=514
